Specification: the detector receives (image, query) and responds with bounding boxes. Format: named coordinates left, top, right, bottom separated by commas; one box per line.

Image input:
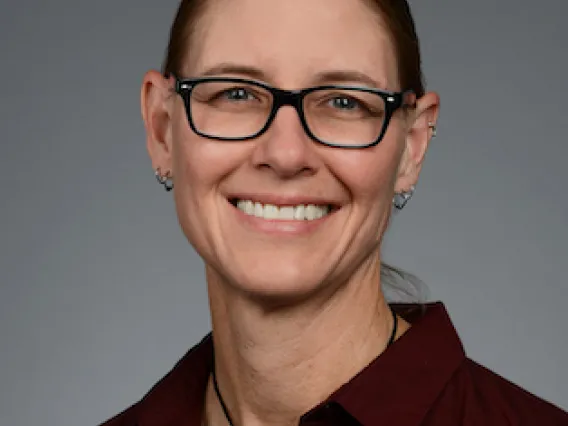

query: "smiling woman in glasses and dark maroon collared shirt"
left=100, top=0, right=568, bottom=426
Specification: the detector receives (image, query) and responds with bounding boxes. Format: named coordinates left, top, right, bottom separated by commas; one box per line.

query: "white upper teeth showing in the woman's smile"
left=233, top=200, right=329, bottom=220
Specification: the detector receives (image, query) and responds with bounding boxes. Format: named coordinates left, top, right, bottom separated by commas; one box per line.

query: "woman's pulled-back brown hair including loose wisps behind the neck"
left=162, top=0, right=427, bottom=302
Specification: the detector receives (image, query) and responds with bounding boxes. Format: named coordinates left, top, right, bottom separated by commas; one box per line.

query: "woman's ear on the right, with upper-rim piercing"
left=395, top=92, right=440, bottom=192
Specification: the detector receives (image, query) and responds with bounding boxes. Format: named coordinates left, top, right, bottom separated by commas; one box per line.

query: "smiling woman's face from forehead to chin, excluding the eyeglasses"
left=143, top=0, right=434, bottom=298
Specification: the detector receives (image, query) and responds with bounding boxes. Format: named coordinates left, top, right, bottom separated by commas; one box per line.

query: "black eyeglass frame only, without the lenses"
left=172, top=75, right=414, bottom=149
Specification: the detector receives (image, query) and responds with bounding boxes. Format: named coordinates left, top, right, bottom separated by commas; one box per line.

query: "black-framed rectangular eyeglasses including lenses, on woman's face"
left=171, top=77, right=415, bottom=148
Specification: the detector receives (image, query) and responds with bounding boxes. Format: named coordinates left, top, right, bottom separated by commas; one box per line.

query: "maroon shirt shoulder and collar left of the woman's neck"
left=100, top=334, right=213, bottom=426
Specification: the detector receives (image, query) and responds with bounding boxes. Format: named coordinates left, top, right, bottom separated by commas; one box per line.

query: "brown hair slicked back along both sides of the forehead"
left=162, top=0, right=424, bottom=97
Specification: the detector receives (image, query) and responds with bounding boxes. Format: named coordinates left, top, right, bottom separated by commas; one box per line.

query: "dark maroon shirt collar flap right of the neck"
left=329, top=303, right=466, bottom=426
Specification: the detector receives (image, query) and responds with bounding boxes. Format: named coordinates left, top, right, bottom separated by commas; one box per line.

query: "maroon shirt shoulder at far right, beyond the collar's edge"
left=430, top=358, right=568, bottom=426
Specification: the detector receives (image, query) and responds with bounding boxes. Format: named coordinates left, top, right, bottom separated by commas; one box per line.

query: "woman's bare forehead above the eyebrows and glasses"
left=184, top=0, right=398, bottom=90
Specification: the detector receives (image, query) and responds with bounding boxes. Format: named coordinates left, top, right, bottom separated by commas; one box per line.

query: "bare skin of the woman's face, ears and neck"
left=142, top=0, right=439, bottom=426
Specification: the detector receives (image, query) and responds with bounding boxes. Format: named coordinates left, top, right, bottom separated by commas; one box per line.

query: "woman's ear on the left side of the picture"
left=140, top=71, right=174, bottom=172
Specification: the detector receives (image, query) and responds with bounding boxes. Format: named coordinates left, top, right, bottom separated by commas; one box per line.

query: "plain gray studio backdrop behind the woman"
left=0, top=0, right=568, bottom=426
